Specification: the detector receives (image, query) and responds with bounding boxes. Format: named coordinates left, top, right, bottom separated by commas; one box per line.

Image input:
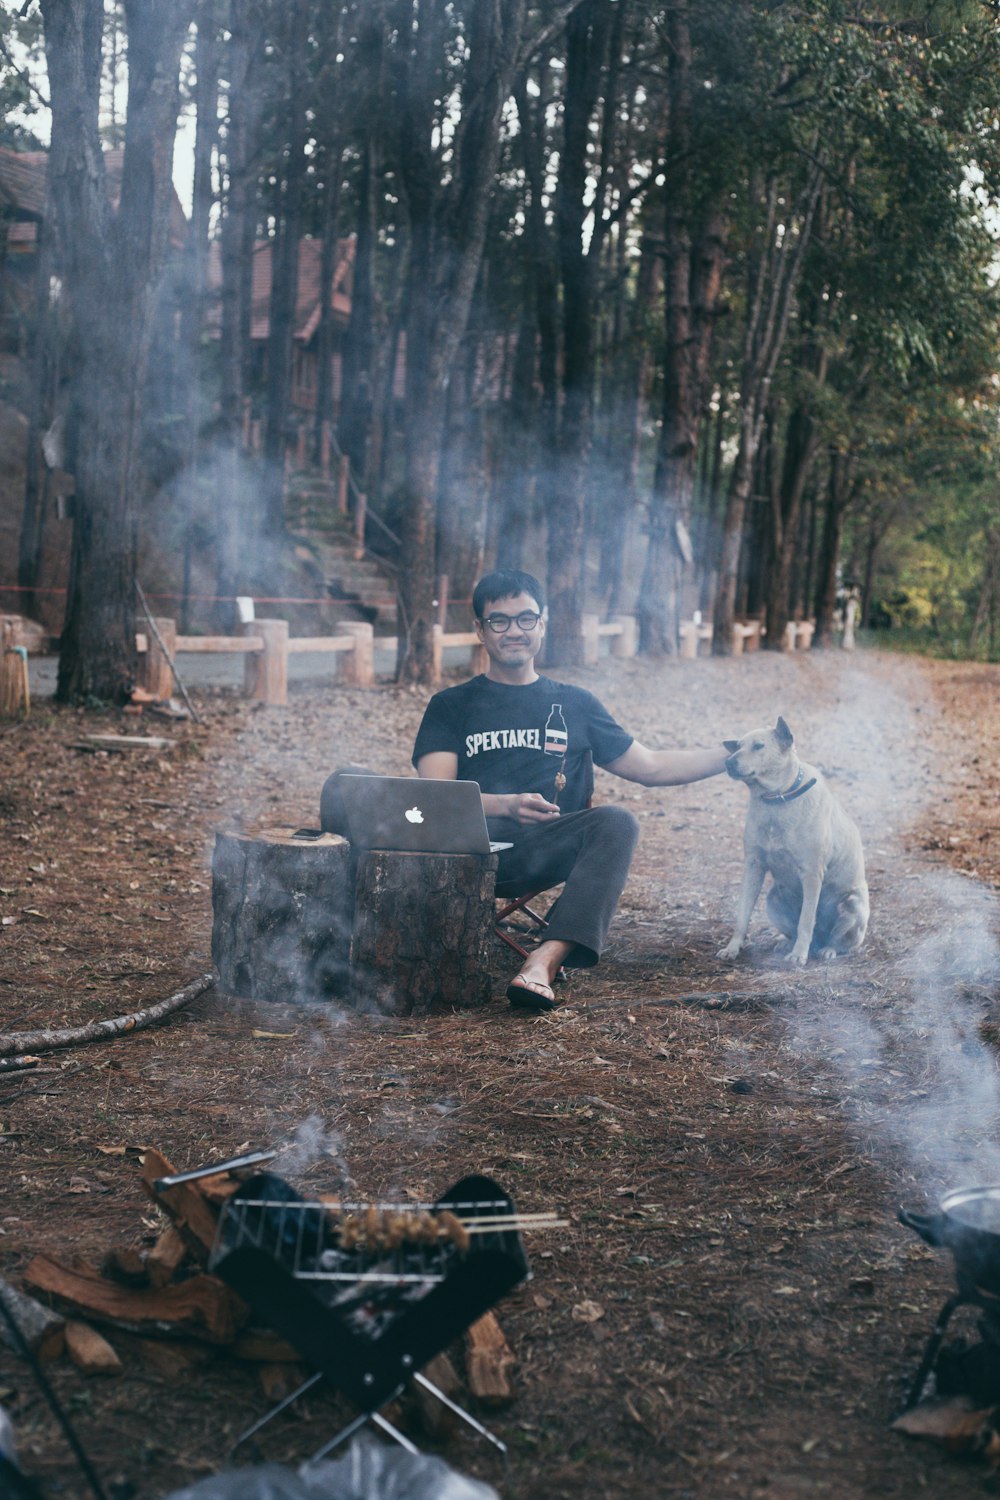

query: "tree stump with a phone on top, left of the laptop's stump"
left=211, top=828, right=352, bottom=1005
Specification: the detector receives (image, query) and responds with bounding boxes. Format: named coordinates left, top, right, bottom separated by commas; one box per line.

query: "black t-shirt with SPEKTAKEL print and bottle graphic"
left=414, top=677, right=633, bottom=813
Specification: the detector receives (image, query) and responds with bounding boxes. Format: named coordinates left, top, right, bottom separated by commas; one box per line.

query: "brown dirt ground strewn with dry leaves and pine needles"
left=0, top=653, right=1000, bottom=1500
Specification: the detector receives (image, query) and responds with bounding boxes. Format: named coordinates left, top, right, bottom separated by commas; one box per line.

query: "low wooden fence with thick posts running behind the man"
left=135, top=614, right=814, bottom=705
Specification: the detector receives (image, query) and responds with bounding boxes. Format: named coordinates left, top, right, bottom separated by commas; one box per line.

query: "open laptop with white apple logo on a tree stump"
left=340, top=773, right=511, bottom=854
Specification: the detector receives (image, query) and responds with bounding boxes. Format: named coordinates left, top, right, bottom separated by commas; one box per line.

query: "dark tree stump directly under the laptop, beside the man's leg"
left=351, top=849, right=496, bottom=1016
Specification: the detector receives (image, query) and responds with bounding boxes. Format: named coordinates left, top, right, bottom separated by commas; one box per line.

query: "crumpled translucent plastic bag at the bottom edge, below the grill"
left=165, top=1437, right=499, bottom=1500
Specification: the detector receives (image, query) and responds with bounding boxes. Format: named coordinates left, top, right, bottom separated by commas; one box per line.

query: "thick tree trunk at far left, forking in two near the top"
left=42, top=0, right=193, bottom=701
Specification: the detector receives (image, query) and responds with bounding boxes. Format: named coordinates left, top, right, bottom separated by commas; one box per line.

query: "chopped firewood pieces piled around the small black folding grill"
left=0, top=1146, right=514, bottom=1437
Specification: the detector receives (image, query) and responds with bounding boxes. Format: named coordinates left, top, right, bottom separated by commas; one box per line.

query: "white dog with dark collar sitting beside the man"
left=718, top=719, right=868, bottom=963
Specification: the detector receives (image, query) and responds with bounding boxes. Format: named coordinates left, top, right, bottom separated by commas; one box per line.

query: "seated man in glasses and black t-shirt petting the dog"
left=412, top=572, right=727, bottom=1011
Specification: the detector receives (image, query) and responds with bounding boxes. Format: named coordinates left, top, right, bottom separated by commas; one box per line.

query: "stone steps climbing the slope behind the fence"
left=286, top=476, right=397, bottom=636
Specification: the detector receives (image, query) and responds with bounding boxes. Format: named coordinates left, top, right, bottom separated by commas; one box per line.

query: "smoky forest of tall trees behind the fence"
left=0, top=0, right=1000, bottom=701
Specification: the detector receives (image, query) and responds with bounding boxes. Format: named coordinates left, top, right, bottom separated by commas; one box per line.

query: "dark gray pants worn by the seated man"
left=489, top=806, right=639, bottom=969
